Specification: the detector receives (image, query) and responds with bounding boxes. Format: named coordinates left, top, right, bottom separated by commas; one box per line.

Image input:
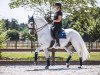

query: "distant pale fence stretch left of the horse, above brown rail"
left=3, top=40, right=38, bottom=49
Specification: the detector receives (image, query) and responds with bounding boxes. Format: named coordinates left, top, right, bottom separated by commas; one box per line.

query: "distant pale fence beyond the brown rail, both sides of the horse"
left=3, top=40, right=100, bottom=49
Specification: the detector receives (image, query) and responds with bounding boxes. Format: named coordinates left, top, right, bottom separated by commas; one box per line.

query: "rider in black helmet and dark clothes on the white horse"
left=53, top=3, right=62, bottom=46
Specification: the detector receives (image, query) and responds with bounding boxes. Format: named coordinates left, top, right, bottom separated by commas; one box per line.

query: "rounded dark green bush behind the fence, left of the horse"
left=7, top=29, right=19, bottom=41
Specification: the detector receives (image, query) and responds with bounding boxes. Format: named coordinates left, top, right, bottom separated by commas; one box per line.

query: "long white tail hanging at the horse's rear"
left=80, top=38, right=90, bottom=61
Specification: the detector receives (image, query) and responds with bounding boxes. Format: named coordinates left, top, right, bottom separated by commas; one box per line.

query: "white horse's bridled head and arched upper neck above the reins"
left=28, top=16, right=47, bottom=34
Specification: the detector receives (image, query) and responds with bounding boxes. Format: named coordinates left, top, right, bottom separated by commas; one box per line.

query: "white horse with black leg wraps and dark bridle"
left=28, top=16, right=89, bottom=69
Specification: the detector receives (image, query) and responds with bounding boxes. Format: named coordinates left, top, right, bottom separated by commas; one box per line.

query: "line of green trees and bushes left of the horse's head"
left=0, top=19, right=28, bottom=46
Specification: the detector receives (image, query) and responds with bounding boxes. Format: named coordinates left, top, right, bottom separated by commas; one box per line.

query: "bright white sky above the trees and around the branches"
left=0, top=0, right=100, bottom=23
